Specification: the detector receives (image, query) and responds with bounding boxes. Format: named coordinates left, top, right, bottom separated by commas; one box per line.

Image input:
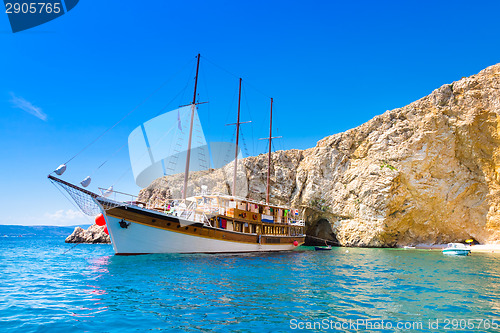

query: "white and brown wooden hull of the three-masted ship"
left=105, top=206, right=305, bottom=255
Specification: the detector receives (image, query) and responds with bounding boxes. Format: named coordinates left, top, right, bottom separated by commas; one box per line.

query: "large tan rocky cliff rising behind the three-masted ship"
left=140, top=64, right=500, bottom=246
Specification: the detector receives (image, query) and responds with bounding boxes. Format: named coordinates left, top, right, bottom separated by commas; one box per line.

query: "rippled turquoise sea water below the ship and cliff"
left=0, top=237, right=500, bottom=332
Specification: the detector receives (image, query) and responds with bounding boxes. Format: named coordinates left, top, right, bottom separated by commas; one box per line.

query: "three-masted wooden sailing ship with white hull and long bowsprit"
left=48, top=54, right=305, bottom=255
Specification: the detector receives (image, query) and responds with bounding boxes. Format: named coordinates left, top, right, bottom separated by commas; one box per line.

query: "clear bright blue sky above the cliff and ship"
left=0, top=0, right=500, bottom=225
